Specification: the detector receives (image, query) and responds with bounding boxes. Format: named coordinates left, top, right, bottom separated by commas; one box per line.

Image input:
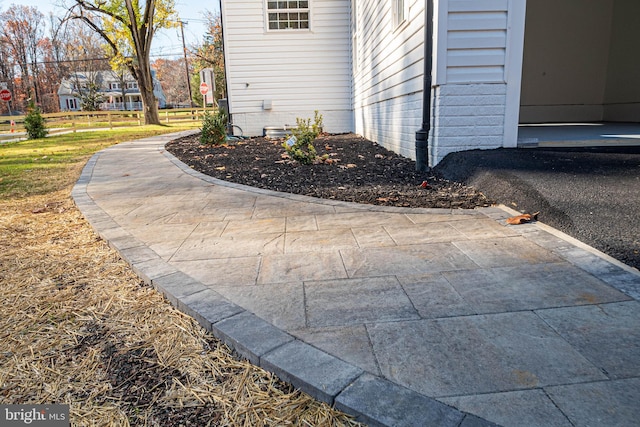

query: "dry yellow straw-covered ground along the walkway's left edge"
left=0, top=165, right=356, bottom=426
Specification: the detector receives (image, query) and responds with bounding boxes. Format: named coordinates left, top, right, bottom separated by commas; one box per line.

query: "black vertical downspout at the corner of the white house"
left=416, top=0, right=433, bottom=172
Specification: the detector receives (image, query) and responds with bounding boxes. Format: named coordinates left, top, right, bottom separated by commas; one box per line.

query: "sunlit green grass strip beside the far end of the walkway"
left=0, top=124, right=195, bottom=199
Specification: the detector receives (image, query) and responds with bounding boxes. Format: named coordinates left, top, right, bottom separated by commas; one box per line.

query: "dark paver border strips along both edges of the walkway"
left=71, top=135, right=495, bottom=427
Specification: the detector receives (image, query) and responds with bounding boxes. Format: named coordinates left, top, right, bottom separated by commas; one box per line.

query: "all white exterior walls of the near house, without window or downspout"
left=222, top=0, right=525, bottom=166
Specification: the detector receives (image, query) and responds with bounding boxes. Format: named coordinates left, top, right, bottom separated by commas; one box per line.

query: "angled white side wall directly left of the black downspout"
left=353, top=0, right=425, bottom=158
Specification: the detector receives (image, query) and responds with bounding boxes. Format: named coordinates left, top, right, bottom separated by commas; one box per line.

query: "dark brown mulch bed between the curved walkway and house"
left=167, top=134, right=493, bottom=209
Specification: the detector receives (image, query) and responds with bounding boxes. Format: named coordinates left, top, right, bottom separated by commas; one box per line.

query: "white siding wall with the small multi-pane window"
left=222, top=0, right=353, bottom=135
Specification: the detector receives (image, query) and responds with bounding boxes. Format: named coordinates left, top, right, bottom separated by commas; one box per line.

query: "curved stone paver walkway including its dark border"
left=73, top=134, right=640, bottom=427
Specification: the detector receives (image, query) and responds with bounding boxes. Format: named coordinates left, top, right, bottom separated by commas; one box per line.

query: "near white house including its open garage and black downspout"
left=222, top=0, right=640, bottom=166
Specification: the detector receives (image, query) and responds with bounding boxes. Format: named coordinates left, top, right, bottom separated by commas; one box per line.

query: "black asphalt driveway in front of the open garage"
left=435, top=146, right=640, bottom=269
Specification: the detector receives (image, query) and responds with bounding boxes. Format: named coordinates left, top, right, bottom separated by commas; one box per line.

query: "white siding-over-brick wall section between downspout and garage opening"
left=429, top=0, right=525, bottom=165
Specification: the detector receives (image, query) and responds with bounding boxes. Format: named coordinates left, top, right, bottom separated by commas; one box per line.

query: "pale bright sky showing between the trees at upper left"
left=0, top=0, right=220, bottom=60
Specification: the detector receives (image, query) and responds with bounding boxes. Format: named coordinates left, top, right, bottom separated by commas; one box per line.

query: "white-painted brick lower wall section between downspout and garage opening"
left=429, top=83, right=507, bottom=166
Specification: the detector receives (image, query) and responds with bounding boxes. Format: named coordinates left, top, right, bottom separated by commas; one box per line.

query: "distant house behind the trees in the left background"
left=58, top=70, right=166, bottom=111
